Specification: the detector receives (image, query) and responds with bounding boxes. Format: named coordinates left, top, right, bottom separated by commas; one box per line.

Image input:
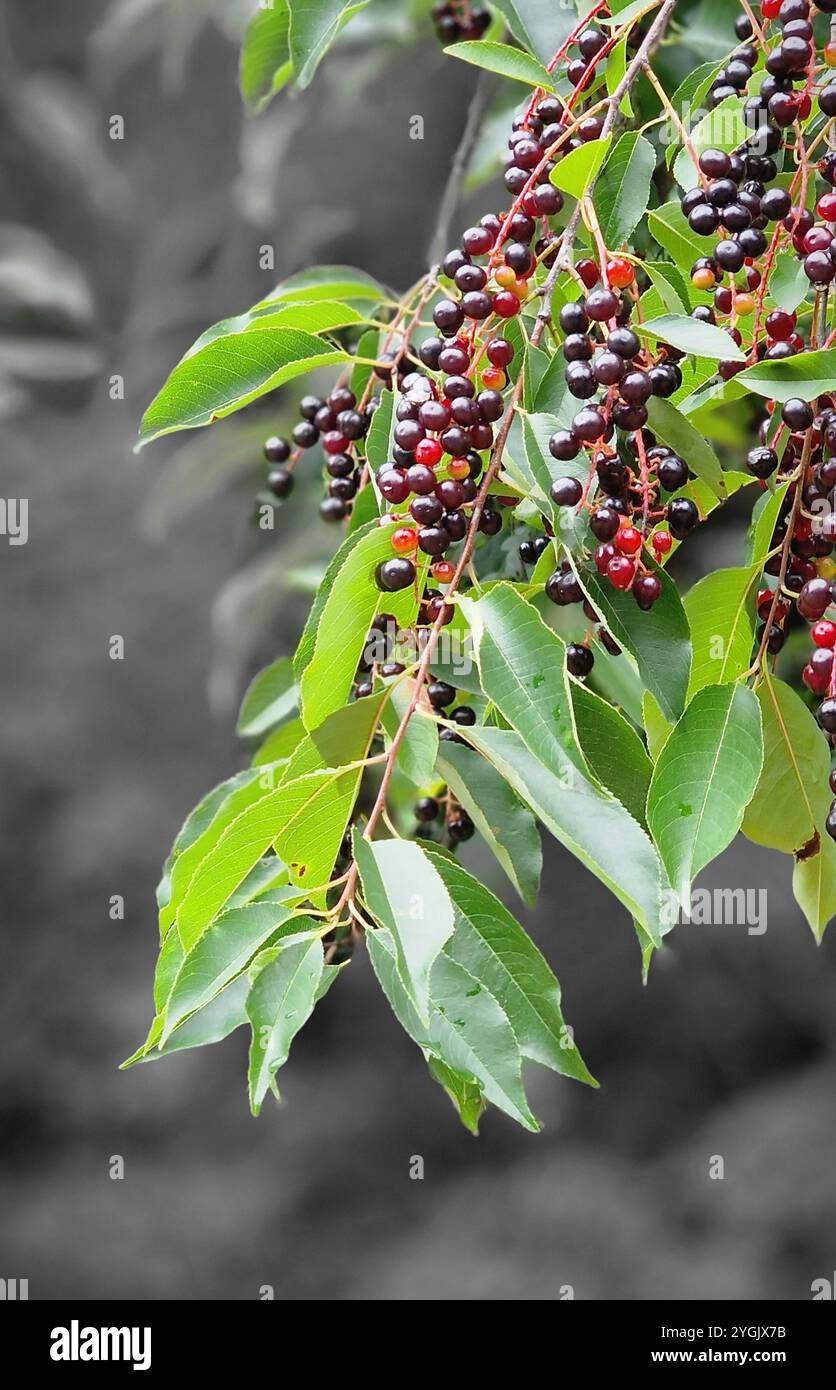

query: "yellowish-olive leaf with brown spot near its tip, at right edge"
left=743, top=671, right=830, bottom=859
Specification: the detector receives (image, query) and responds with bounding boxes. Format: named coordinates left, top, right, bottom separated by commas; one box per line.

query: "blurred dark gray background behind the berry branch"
left=0, top=0, right=836, bottom=1300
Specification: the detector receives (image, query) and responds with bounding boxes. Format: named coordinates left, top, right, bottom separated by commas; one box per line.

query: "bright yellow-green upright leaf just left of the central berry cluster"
left=299, top=523, right=417, bottom=728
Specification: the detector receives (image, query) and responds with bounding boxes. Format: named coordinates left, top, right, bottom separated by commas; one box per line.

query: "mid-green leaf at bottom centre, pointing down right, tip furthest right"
left=427, top=847, right=595, bottom=1086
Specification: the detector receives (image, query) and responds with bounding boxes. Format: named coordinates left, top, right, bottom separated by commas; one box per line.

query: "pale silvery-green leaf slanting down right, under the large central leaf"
left=463, top=726, right=666, bottom=945
